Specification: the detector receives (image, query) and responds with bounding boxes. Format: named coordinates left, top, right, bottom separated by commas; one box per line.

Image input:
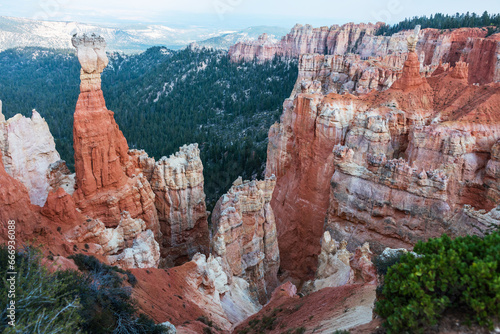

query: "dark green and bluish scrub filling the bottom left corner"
left=0, top=247, right=167, bottom=334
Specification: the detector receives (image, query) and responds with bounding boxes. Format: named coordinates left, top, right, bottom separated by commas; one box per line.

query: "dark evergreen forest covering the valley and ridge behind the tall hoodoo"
left=0, top=47, right=298, bottom=210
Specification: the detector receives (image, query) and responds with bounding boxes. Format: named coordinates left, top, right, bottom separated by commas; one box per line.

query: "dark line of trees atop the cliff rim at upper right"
left=376, top=11, right=500, bottom=36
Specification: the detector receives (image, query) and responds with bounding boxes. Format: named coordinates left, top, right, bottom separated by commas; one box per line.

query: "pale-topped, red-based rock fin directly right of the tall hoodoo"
left=150, top=144, right=210, bottom=267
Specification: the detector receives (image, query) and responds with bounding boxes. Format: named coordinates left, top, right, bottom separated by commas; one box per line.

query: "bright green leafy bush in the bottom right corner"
left=376, top=232, right=500, bottom=334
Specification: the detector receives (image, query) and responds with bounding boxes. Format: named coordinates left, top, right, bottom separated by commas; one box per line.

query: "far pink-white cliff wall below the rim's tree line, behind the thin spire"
left=229, top=23, right=500, bottom=94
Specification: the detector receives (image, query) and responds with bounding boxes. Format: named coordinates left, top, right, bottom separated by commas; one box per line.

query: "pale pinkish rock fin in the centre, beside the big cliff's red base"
left=212, top=176, right=280, bottom=304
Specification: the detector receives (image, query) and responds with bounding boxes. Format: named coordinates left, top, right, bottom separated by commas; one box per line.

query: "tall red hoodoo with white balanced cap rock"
left=73, top=36, right=160, bottom=237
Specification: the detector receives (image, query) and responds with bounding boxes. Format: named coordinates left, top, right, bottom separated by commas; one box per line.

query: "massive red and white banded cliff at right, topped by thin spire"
left=267, top=27, right=500, bottom=279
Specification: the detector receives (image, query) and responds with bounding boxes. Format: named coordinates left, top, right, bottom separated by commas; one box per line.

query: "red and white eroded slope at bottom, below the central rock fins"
left=132, top=254, right=261, bottom=333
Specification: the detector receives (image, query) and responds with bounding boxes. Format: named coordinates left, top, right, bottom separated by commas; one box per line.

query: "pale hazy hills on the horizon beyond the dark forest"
left=0, top=16, right=288, bottom=53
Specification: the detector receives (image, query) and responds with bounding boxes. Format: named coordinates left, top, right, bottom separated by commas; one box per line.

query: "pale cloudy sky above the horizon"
left=0, top=0, right=500, bottom=30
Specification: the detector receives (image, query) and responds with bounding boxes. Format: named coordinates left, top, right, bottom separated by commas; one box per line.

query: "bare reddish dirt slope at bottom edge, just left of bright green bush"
left=234, top=282, right=376, bottom=333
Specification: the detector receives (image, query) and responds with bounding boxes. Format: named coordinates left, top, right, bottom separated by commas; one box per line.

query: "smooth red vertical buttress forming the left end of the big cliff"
left=266, top=94, right=344, bottom=278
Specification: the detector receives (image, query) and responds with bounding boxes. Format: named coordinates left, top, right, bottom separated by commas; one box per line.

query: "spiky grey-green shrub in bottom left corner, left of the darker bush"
left=0, top=245, right=82, bottom=333
